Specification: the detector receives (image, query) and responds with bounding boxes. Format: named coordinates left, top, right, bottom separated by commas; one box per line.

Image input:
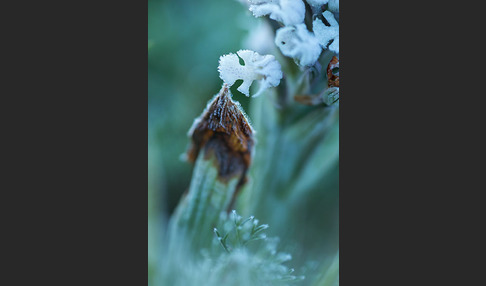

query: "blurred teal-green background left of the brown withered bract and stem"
left=148, top=0, right=258, bottom=285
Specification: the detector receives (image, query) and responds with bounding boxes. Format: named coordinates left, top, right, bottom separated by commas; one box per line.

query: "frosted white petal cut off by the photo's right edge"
left=312, top=11, right=339, bottom=54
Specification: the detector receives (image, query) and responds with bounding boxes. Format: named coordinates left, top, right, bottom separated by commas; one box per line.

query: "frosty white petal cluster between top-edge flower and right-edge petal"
left=275, top=24, right=322, bottom=66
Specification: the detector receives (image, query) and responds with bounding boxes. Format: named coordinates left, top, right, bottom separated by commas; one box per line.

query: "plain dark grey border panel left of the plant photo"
left=7, top=1, right=148, bottom=285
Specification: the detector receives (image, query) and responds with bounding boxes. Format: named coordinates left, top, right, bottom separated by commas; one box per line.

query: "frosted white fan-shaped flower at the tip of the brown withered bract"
left=218, top=50, right=283, bottom=97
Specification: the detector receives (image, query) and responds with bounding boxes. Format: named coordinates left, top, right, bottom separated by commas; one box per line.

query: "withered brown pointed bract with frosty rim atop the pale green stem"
left=187, top=84, right=254, bottom=183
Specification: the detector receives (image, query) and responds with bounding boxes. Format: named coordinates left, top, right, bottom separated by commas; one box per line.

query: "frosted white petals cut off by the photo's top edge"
left=248, top=0, right=305, bottom=26
